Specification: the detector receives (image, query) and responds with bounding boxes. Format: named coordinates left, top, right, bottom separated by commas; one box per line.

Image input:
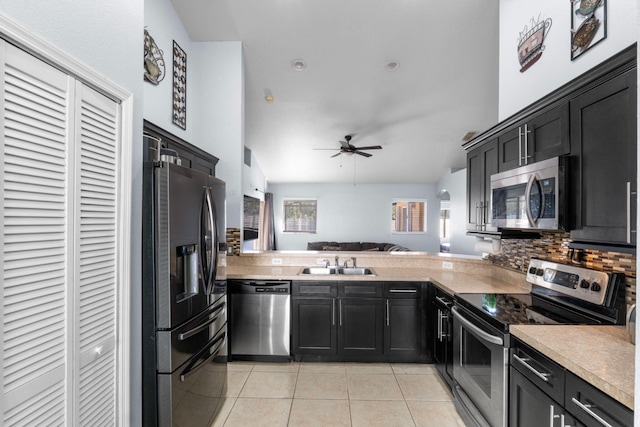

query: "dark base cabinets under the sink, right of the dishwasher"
left=291, top=281, right=426, bottom=362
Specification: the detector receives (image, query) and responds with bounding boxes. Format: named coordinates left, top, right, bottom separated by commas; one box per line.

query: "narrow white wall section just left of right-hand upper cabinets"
left=436, top=169, right=481, bottom=255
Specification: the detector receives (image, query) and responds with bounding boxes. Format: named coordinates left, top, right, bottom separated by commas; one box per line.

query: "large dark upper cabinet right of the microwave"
left=570, top=67, right=637, bottom=245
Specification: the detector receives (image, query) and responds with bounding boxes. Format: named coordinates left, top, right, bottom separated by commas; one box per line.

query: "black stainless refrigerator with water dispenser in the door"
left=141, top=156, right=228, bottom=427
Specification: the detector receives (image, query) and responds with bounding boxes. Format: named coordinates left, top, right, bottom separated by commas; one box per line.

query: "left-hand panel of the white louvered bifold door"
left=0, top=41, right=70, bottom=425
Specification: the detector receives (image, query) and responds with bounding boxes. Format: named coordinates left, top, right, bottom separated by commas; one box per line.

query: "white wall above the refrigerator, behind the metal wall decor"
left=144, top=0, right=244, bottom=231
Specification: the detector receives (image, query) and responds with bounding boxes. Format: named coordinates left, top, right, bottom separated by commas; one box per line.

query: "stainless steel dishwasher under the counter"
left=228, top=280, right=291, bottom=360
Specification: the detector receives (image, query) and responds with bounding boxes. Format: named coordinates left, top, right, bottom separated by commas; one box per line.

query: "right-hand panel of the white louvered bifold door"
left=76, top=86, right=118, bottom=425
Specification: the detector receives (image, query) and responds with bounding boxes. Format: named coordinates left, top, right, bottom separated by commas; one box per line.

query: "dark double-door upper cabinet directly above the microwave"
left=498, top=102, right=571, bottom=172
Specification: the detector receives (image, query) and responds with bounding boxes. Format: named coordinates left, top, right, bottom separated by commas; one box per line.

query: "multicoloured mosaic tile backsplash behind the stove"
left=490, top=232, right=636, bottom=304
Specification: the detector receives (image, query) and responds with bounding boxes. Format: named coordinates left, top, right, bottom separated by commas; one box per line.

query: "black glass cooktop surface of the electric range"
left=455, top=294, right=602, bottom=332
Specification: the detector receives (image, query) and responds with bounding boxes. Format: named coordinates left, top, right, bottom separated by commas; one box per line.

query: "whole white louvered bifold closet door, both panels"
left=0, top=40, right=118, bottom=426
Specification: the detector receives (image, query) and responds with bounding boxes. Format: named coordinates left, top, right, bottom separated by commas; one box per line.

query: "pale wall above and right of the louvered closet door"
left=0, top=0, right=143, bottom=425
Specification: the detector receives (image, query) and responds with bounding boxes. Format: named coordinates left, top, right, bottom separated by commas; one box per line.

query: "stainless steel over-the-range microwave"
left=491, top=157, right=568, bottom=230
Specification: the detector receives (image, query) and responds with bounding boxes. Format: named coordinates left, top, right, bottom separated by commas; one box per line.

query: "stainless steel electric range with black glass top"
left=452, top=259, right=626, bottom=427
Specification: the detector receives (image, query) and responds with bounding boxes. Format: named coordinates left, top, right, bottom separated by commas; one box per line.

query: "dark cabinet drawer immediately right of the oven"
left=511, top=339, right=566, bottom=403
